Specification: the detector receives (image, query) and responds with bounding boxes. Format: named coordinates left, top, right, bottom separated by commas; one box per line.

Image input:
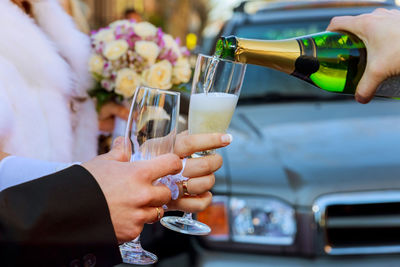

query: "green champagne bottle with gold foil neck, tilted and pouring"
left=215, top=32, right=400, bottom=97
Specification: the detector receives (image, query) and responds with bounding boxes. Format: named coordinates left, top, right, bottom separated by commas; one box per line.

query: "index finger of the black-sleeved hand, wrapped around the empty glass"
left=136, top=154, right=182, bottom=183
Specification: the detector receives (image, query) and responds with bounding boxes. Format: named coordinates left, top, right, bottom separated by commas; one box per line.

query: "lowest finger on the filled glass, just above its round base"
left=168, top=192, right=212, bottom=213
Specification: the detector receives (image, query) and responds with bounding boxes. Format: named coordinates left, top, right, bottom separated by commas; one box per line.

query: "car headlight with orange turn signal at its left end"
left=198, top=196, right=297, bottom=246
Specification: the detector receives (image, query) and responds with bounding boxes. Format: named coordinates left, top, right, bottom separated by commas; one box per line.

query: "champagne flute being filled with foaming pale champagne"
left=161, top=54, right=246, bottom=235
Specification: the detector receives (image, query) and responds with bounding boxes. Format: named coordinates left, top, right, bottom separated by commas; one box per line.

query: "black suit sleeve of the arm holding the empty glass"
left=0, top=165, right=121, bottom=267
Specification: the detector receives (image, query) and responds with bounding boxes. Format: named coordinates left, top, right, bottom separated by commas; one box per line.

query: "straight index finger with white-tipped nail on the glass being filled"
left=174, top=133, right=233, bottom=158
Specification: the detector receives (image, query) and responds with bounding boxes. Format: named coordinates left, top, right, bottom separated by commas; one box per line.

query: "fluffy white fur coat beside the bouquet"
left=0, top=0, right=98, bottom=162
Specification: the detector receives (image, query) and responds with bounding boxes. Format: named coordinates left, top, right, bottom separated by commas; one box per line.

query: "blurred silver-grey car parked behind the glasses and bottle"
left=192, top=1, right=400, bottom=267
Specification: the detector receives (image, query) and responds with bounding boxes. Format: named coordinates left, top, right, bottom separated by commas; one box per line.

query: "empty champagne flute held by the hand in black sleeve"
left=120, top=86, right=180, bottom=265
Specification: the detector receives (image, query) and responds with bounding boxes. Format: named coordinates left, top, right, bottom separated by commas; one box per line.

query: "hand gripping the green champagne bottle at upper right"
left=327, top=8, right=400, bottom=104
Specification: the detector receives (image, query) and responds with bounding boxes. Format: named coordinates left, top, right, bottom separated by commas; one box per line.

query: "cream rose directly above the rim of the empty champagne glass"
left=142, top=60, right=172, bottom=89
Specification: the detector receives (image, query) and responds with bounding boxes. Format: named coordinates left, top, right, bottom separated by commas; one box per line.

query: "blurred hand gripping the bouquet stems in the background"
left=98, top=102, right=129, bottom=133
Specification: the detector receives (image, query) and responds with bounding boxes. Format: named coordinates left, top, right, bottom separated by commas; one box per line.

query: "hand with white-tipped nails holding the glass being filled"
left=167, top=132, right=232, bottom=213
